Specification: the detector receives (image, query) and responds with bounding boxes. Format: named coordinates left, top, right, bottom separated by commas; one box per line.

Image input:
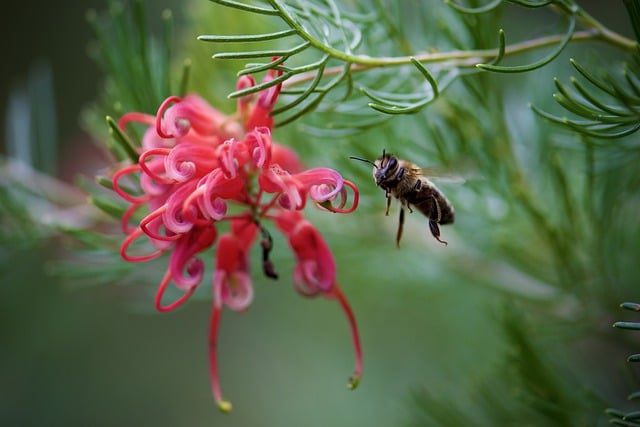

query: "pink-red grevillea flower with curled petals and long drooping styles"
left=113, top=67, right=362, bottom=411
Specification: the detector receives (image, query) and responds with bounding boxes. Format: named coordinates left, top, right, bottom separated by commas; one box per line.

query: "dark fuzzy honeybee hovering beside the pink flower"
left=349, top=150, right=455, bottom=248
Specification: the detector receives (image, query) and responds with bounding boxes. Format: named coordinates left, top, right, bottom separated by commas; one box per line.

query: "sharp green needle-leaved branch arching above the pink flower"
left=199, top=0, right=635, bottom=129
